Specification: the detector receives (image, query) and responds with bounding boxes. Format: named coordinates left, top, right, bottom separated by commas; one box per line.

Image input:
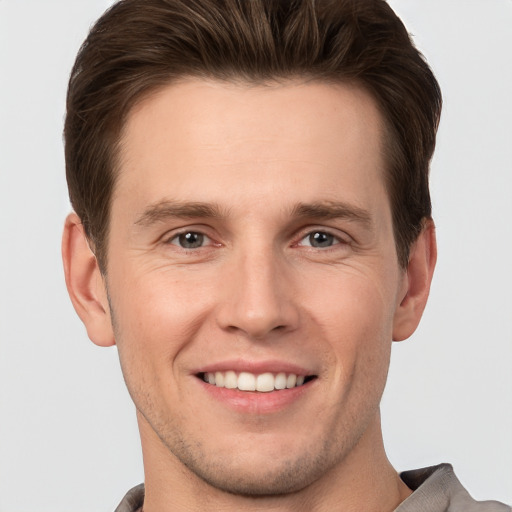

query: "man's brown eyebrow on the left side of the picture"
left=135, top=201, right=225, bottom=226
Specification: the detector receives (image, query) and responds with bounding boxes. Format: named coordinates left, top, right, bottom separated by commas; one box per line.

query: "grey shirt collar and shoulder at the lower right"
left=396, top=464, right=512, bottom=512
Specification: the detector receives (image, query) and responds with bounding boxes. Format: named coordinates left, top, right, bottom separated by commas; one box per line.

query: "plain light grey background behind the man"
left=0, top=0, right=512, bottom=512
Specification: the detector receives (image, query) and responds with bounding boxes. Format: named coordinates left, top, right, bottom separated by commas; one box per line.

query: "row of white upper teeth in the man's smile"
left=203, top=370, right=304, bottom=392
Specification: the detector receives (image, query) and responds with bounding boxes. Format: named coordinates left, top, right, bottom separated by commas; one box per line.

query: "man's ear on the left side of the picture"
left=62, top=213, right=115, bottom=347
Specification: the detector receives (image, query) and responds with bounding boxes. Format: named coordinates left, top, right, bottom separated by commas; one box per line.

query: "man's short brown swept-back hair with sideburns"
left=64, top=0, right=441, bottom=271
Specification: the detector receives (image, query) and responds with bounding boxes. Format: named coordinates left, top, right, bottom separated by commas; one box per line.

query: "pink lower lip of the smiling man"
left=197, top=378, right=317, bottom=414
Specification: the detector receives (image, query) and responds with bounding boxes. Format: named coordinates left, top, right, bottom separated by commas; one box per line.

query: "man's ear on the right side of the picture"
left=393, top=219, right=437, bottom=341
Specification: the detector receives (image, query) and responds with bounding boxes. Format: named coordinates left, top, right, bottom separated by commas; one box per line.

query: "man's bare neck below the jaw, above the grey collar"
left=139, top=413, right=411, bottom=512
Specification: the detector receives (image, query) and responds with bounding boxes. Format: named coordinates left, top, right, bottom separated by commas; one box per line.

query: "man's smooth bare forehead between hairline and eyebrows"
left=114, top=79, right=384, bottom=215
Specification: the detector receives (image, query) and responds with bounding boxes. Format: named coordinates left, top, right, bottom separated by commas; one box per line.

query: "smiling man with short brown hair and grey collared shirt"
left=63, top=0, right=510, bottom=512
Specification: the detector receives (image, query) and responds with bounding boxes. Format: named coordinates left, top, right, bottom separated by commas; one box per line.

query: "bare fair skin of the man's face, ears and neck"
left=63, top=79, right=436, bottom=512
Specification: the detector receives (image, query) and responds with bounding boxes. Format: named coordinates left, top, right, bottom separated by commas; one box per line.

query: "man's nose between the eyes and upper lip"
left=217, top=247, right=299, bottom=340
